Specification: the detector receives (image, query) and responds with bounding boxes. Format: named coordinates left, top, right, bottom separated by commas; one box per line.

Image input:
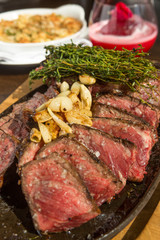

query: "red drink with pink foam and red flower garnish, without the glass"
left=89, top=2, right=158, bottom=52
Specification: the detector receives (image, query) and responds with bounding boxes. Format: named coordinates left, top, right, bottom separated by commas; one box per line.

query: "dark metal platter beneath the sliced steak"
left=0, top=86, right=160, bottom=240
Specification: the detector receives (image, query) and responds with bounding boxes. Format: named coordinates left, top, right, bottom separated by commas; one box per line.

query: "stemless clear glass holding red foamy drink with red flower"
left=89, top=0, right=158, bottom=52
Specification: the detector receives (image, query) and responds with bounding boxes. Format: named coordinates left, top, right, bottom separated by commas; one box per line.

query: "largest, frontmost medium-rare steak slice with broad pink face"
left=22, top=153, right=100, bottom=232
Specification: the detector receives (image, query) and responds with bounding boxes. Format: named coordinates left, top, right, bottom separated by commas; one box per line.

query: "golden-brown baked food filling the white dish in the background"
left=0, top=13, right=82, bottom=43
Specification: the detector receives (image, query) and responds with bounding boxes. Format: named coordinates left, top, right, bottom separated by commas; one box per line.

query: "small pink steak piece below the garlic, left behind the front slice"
left=18, top=141, right=44, bottom=167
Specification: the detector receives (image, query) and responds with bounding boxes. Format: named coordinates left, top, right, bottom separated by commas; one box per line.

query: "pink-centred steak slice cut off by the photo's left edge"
left=0, top=130, right=17, bottom=176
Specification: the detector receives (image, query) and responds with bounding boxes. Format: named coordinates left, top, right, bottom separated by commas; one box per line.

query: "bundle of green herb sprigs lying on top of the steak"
left=29, top=44, right=156, bottom=91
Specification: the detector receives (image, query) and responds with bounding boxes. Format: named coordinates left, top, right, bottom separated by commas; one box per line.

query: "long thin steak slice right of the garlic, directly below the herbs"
left=97, top=94, right=159, bottom=127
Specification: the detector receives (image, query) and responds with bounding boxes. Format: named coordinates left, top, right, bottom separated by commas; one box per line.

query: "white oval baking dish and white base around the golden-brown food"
left=0, top=4, right=87, bottom=64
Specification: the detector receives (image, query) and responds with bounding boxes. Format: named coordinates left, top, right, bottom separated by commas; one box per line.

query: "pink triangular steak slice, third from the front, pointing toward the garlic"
left=71, top=124, right=137, bottom=185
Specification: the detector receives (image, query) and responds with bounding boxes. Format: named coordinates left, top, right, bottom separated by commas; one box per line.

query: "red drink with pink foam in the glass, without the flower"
left=89, top=21, right=158, bottom=52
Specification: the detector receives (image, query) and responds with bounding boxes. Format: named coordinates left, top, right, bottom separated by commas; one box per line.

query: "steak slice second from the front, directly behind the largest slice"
left=37, top=137, right=123, bottom=205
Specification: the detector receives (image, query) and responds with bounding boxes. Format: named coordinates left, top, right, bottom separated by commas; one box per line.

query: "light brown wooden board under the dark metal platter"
left=0, top=79, right=160, bottom=240
